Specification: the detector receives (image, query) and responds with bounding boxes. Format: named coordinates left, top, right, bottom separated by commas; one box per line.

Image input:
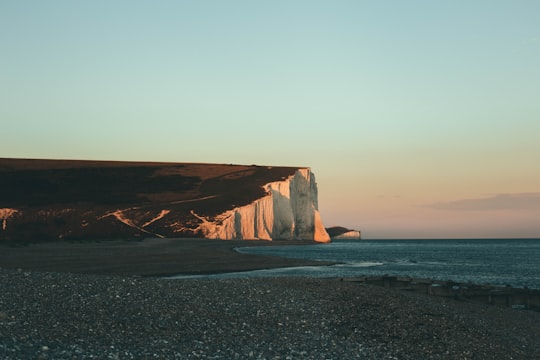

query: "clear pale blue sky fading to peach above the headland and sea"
left=0, top=0, right=540, bottom=238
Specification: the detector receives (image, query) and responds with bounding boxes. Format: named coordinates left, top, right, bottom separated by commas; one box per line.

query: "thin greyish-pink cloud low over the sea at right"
left=425, top=192, right=540, bottom=211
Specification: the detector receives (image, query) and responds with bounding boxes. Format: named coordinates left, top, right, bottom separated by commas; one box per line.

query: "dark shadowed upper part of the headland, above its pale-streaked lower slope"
left=0, top=158, right=299, bottom=213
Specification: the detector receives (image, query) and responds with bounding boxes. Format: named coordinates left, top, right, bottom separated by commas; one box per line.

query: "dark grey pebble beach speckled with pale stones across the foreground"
left=0, top=268, right=540, bottom=360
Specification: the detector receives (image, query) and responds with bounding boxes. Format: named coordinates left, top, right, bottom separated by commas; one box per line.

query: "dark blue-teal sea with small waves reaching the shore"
left=170, top=239, right=540, bottom=289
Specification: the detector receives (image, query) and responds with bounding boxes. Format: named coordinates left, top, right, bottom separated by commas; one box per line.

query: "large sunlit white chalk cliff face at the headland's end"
left=193, top=168, right=330, bottom=242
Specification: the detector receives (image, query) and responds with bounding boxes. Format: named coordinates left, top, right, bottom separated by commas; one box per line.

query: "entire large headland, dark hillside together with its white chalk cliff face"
left=0, top=159, right=330, bottom=242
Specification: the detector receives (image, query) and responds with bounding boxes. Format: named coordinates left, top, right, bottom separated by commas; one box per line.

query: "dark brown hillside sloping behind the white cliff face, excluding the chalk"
left=0, top=159, right=298, bottom=241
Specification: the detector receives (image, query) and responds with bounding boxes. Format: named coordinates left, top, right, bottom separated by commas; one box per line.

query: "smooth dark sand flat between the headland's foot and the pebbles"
left=0, top=239, right=327, bottom=276
